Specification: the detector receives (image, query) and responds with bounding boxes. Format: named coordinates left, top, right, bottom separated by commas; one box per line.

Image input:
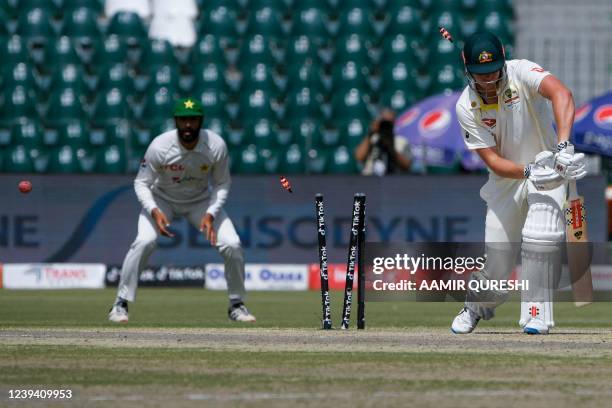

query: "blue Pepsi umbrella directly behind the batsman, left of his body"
left=395, top=92, right=484, bottom=170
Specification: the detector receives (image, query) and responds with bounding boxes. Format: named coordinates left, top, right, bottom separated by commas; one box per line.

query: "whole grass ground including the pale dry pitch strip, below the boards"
left=0, top=288, right=612, bottom=408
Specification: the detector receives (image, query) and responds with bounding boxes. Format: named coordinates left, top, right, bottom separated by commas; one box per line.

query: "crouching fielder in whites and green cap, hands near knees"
left=108, top=98, right=255, bottom=323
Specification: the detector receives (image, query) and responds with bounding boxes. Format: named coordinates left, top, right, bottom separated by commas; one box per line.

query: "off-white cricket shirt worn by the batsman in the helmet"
left=456, top=60, right=557, bottom=168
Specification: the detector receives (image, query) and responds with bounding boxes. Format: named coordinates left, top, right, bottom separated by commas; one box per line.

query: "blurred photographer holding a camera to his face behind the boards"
left=355, top=109, right=411, bottom=176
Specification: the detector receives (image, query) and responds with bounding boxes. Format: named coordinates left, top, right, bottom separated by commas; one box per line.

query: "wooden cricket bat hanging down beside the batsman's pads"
left=563, top=180, right=593, bottom=307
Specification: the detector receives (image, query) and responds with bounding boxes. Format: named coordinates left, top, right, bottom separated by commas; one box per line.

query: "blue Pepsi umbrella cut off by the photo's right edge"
left=573, top=92, right=612, bottom=156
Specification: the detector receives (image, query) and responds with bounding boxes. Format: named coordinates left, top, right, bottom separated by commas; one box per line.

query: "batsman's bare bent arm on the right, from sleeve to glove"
left=538, top=75, right=576, bottom=143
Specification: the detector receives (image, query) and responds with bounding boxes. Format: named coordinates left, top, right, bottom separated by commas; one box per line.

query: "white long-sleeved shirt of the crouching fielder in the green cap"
left=134, top=129, right=231, bottom=217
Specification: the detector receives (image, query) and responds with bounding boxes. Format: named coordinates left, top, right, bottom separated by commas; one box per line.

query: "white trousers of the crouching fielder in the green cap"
left=117, top=196, right=245, bottom=303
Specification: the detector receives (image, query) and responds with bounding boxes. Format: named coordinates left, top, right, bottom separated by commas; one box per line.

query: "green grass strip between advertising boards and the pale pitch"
left=0, top=288, right=612, bottom=328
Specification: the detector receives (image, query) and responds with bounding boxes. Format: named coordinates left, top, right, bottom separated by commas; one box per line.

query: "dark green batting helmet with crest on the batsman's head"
left=463, top=31, right=506, bottom=74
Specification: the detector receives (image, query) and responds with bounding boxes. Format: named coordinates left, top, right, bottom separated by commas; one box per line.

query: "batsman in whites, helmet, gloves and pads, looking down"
left=451, top=32, right=586, bottom=334
